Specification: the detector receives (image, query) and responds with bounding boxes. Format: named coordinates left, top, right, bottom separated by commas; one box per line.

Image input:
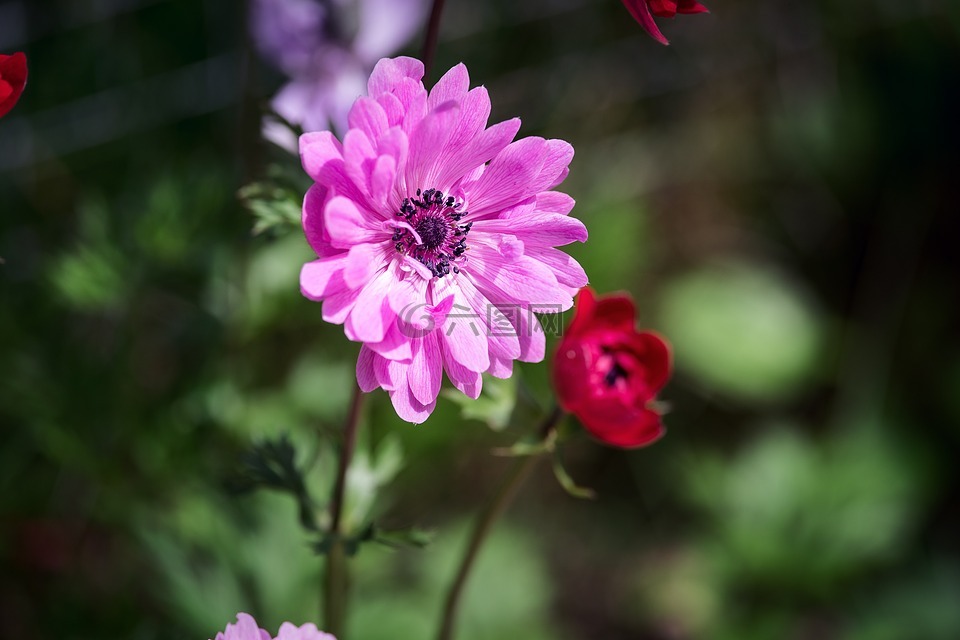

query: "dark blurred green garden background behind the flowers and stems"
left=0, top=0, right=960, bottom=640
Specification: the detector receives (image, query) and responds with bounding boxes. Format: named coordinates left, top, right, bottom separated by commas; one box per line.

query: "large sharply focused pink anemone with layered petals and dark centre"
left=300, top=58, right=587, bottom=423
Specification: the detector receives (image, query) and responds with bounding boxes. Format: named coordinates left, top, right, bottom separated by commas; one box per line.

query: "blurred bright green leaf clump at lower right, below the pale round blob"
left=686, top=427, right=925, bottom=597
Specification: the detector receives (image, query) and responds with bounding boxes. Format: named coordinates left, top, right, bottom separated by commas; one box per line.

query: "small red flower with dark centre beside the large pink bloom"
left=553, top=288, right=671, bottom=448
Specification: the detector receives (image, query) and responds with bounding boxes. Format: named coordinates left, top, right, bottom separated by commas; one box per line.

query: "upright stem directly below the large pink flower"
left=323, top=387, right=363, bottom=640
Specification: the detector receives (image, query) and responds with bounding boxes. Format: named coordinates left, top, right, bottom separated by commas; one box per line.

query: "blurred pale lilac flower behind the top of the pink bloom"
left=250, top=0, right=427, bottom=141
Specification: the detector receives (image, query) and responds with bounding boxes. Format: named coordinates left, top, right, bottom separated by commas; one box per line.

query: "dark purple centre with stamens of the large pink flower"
left=393, top=189, right=473, bottom=278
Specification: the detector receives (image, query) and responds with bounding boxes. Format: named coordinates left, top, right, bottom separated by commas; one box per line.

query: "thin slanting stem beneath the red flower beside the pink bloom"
left=437, top=407, right=564, bottom=640
